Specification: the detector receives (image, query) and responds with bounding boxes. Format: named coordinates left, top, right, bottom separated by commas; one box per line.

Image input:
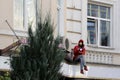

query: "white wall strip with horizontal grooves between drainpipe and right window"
left=65, top=0, right=82, bottom=48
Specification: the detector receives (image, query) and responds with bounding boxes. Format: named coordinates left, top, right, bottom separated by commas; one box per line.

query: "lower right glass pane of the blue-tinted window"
left=100, top=20, right=110, bottom=46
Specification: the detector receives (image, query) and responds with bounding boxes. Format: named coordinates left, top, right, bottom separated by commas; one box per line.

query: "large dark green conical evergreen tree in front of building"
left=11, top=14, right=64, bottom=80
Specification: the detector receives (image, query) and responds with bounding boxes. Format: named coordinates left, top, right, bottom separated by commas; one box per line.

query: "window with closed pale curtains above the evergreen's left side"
left=14, top=0, right=36, bottom=29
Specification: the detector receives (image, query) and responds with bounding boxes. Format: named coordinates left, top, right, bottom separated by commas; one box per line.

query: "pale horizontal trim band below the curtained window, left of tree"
left=0, top=30, right=28, bottom=37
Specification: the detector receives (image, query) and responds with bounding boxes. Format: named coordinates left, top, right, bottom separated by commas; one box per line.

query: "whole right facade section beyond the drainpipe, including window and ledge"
left=60, top=0, right=120, bottom=79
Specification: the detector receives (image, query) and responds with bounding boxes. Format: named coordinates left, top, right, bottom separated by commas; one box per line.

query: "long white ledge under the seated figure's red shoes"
left=61, top=63, right=120, bottom=80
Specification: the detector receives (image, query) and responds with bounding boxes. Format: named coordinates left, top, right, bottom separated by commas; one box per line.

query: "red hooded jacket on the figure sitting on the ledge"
left=73, top=40, right=86, bottom=60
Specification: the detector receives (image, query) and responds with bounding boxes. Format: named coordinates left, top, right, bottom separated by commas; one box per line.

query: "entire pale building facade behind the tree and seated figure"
left=0, top=0, right=120, bottom=79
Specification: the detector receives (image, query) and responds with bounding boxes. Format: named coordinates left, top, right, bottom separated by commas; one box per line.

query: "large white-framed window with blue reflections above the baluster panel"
left=87, top=3, right=111, bottom=47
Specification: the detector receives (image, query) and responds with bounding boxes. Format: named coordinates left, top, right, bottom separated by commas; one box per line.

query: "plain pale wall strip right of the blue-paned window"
left=109, top=0, right=120, bottom=53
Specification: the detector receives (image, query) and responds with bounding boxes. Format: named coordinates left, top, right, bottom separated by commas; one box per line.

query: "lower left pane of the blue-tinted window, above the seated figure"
left=87, top=21, right=97, bottom=44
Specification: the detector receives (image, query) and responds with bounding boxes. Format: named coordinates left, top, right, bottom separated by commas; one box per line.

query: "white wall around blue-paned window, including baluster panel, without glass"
left=65, top=0, right=120, bottom=69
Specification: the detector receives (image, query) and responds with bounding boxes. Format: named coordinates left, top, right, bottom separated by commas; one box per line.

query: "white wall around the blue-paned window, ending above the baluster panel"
left=65, top=0, right=120, bottom=53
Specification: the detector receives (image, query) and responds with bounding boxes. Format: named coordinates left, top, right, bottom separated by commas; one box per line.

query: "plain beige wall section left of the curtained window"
left=0, top=0, right=13, bottom=30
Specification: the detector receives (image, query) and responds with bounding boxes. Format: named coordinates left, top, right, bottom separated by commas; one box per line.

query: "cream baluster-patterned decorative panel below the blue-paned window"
left=86, top=51, right=113, bottom=64
